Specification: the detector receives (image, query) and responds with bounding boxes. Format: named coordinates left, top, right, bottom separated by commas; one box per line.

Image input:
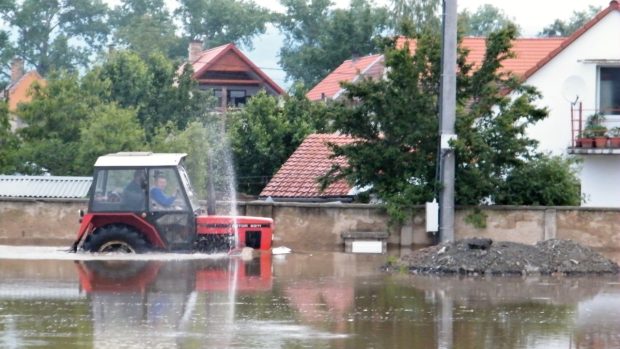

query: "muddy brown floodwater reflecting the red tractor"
left=0, top=247, right=620, bottom=349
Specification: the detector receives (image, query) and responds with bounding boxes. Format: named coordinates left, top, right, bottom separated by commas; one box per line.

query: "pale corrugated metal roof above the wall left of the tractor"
left=0, top=175, right=93, bottom=199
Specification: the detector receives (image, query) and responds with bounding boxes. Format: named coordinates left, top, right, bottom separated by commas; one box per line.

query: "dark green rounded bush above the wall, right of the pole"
left=495, top=154, right=581, bottom=206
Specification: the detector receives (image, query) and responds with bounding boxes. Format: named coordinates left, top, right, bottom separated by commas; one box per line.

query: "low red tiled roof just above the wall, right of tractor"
left=260, top=133, right=353, bottom=198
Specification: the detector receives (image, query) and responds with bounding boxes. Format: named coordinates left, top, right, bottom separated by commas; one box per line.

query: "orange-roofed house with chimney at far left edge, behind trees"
left=2, top=57, right=45, bottom=130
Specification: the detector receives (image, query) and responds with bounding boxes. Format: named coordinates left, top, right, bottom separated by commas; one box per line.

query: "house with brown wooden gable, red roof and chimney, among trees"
left=188, top=41, right=284, bottom=108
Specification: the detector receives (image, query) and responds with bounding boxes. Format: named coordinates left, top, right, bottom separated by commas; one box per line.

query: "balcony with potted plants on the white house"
left=568, top=103, right=620, bottom=155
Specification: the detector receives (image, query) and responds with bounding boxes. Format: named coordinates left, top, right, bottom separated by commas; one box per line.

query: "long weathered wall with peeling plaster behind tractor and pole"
left=0, top=199, right=620, bottom=249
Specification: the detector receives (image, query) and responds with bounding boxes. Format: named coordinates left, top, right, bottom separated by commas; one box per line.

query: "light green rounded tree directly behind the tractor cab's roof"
left=75, top=104, right=145, bottom=173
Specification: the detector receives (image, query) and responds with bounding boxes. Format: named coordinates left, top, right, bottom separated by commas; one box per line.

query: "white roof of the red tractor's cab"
left=95, top=152, right=187, bottom=167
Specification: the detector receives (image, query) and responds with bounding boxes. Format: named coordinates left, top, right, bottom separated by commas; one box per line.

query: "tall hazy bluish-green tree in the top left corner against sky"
left=0, top=0, right=108, bottom=76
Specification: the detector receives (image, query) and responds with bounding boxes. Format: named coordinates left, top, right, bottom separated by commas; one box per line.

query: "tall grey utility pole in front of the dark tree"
left=439, top=0, right=456, bottom=242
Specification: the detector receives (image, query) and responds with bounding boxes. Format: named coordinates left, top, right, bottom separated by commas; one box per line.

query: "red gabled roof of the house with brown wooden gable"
left=190, top=43, right=284, bottom=94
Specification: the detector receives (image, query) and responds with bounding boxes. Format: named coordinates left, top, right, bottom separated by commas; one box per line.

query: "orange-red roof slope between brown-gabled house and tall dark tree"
left=306, top=54, right=383, bottom=101
